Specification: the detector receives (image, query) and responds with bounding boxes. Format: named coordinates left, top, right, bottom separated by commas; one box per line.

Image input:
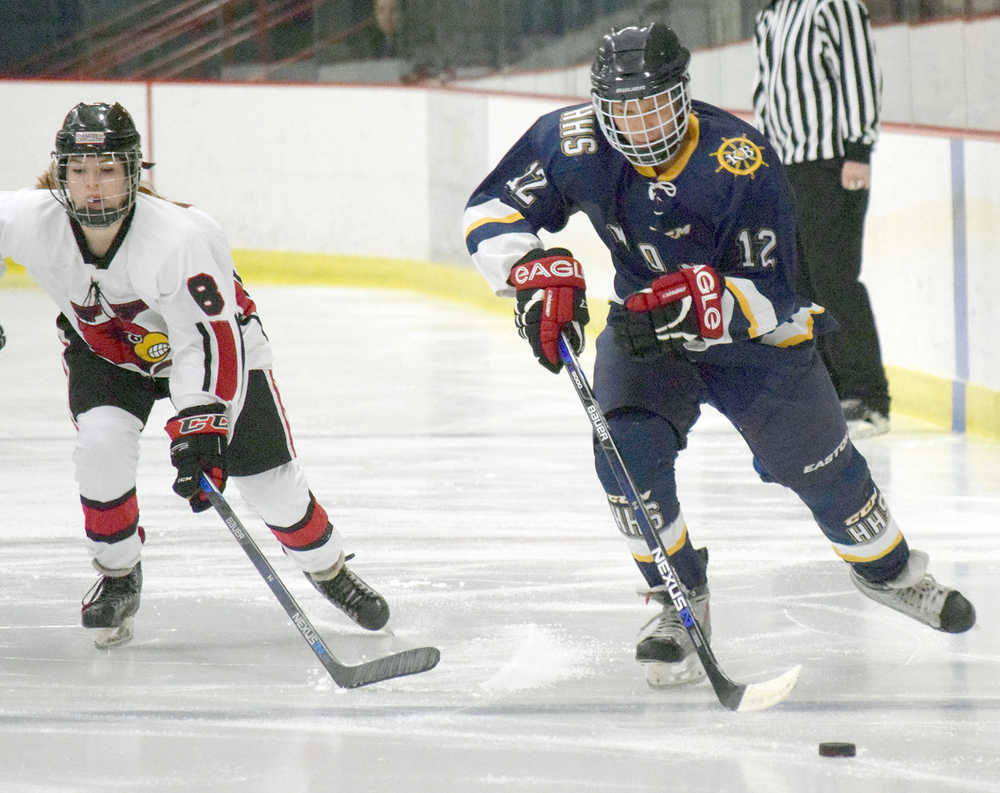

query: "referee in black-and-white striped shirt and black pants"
left=753, top=0, right=889, bottom=438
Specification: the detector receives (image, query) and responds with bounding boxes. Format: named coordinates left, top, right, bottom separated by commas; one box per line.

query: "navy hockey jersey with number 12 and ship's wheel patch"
left=464, top=101, right=825, bottom=352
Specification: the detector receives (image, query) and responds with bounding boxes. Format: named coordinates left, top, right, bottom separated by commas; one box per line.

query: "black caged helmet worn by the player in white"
left=52, top=102, right=142, bottom=227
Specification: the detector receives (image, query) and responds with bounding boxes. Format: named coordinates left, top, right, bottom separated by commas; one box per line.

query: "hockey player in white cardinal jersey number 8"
left=0, top=102, right=389, bottom=647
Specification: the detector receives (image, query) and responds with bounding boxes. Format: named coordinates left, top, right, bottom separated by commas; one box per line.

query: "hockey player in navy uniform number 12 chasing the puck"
left=464, top=23, right=975, bottom=687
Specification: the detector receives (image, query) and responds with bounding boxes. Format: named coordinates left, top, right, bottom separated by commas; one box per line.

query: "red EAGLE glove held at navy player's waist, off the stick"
left=612, top=264, right=724, bottom=358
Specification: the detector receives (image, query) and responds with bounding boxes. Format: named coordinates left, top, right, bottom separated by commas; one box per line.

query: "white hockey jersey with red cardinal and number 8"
left=0, top=189, right=272, bottom=411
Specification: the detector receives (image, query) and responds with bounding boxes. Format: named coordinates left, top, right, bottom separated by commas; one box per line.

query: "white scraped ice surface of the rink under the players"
left=0, top=285, right=1000, bottom=793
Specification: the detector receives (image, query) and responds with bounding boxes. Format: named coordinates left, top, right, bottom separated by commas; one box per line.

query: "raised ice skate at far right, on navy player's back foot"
left=851, top=550, right=976, bottom=633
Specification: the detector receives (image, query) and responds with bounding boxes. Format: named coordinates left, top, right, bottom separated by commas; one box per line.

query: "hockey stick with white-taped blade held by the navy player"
left=559, top=331, right=802, bottom=712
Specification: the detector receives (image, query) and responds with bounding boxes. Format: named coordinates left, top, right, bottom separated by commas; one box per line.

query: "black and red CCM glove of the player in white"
left=165, top=405, right=229, bottom=512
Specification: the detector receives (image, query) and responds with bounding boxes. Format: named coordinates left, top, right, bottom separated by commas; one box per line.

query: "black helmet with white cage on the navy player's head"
left=590, top=22, right=691, bottom=166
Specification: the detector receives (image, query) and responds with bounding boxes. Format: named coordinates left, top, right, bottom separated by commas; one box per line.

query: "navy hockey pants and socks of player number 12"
left=594, top=328, right=909, bottom=587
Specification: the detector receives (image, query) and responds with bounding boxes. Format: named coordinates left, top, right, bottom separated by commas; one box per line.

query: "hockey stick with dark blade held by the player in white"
left=201, top=474, right=441, bottom=688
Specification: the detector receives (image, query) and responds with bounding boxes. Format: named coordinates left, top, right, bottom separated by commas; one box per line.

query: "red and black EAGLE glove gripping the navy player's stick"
left=507, top=248, right=590, bottom=372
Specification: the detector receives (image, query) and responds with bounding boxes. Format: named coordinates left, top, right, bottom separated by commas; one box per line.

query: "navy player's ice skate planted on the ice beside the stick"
left=635, top=584, right=712, bottom=688
